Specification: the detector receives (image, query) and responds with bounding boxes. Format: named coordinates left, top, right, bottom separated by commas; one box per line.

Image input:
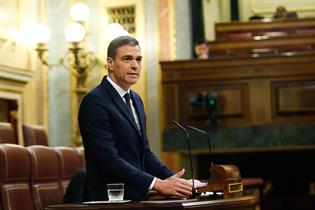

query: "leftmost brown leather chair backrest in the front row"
left=0, top=144, right=35, bottom=210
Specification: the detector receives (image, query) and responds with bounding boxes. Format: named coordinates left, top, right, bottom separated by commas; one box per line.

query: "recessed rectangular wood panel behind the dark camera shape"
left=179, top=81, right=249, bottom=128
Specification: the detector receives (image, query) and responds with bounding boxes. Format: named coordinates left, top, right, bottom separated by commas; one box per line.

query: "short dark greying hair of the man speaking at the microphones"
left=107, top=36, right=140, bottom=60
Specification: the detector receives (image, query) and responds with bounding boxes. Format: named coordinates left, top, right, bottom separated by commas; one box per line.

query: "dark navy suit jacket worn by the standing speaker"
left=78, top=77, right=173, bottom=201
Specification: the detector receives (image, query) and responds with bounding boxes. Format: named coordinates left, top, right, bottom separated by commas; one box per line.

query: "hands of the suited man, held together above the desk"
left=153, top=169, right=192, bottom=198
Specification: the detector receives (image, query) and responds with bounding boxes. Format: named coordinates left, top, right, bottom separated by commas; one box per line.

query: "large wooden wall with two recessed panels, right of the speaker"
left=161, top=53, right=315, bottom=127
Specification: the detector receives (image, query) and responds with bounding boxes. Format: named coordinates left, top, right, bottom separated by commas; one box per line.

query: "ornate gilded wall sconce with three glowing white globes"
left=35, top=3, right=99, bottom=102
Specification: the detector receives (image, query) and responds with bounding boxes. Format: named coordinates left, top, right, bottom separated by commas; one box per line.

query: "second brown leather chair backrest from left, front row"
left=27, top=145, right=63, bottom=210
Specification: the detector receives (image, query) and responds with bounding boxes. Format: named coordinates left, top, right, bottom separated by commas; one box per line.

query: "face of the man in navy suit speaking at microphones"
left=107, top=45, right=142, bottom=91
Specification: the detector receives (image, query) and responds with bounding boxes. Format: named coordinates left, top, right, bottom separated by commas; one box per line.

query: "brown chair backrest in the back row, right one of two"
left=23, top=124, right=48, bottom=146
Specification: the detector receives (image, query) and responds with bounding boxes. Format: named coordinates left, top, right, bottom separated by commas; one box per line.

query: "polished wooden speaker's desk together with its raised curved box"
left=45, top=165, right=258, bottom=210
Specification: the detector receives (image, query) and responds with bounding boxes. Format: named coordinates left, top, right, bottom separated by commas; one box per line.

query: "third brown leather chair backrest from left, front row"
left=55, top=147, right=83, bottom=193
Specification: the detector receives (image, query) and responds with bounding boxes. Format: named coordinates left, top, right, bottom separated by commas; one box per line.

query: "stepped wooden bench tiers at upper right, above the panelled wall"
left=209, top=18, right=315, bottom=57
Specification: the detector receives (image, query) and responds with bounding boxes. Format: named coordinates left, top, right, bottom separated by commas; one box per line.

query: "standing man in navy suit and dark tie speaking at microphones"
left=78, top=36, right=192, bottom=201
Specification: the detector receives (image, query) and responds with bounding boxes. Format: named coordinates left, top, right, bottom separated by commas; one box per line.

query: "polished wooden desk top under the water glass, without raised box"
left=45, top=196, right=258, bottom=210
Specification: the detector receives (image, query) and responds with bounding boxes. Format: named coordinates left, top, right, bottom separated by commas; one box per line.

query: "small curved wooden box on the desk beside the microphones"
left=196, top=165, right=243, bottom=198
